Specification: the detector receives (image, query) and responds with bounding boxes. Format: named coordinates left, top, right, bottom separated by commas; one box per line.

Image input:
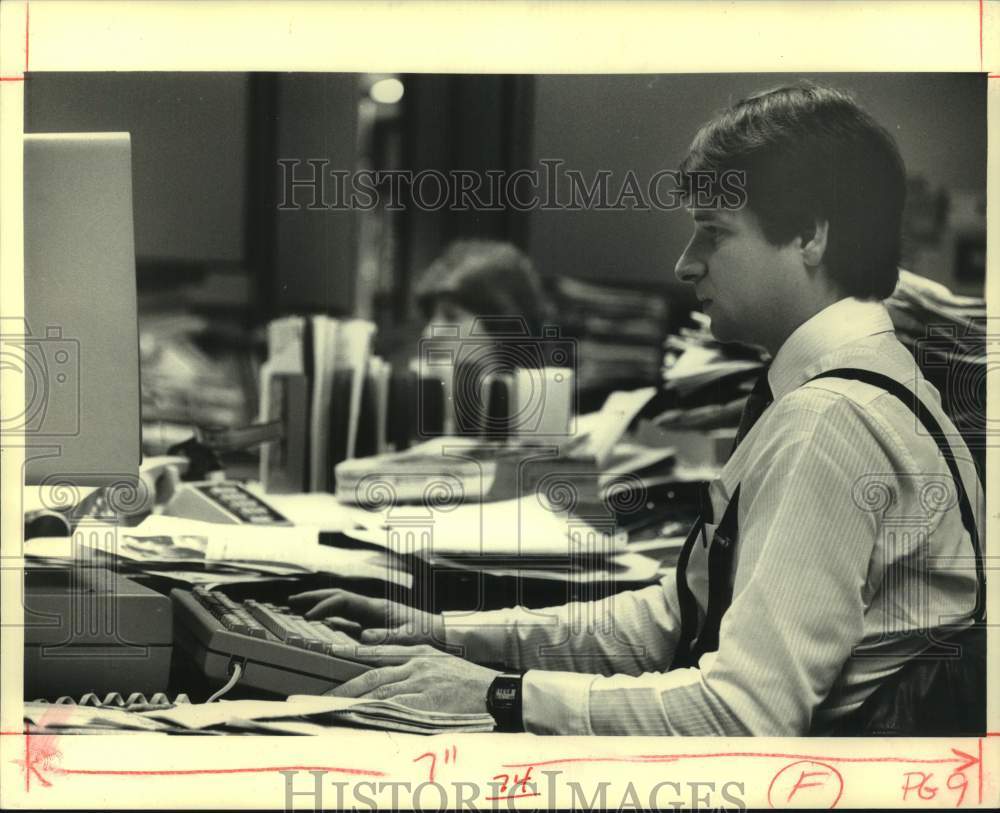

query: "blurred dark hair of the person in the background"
left=416, top=239, right=549, bottom=336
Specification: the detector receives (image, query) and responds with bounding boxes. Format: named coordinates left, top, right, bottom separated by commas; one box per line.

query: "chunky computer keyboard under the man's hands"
left=170, top=586, right=371, bottom=696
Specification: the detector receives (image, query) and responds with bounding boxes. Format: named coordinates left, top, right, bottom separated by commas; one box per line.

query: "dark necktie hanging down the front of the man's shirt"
left=673, top=367, right=774, bottom=668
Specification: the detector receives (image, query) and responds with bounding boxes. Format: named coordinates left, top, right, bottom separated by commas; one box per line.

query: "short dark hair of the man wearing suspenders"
left=680, top=83, right=906, bottom=299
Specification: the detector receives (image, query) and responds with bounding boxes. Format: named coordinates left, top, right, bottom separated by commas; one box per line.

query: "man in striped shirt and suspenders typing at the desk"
left=297, top=85, right=984, bottom=736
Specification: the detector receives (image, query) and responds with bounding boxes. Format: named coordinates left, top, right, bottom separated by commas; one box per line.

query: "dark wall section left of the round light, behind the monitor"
left=25, top=73, right=358, bottom=318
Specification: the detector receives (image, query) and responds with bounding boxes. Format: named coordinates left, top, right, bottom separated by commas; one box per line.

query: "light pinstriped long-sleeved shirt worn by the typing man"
left=445, top=299, right=985, bottom=736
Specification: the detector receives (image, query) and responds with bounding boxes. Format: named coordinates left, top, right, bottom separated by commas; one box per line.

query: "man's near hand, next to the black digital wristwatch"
left=327, top=647, right=501, bottom=714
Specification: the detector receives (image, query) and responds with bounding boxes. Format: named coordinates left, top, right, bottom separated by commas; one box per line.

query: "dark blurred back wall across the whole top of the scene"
left=25, top=73, right=986, bottom=322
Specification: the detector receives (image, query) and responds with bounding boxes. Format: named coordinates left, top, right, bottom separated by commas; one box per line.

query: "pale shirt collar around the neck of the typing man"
left=767, top=297, right=894, bottom=400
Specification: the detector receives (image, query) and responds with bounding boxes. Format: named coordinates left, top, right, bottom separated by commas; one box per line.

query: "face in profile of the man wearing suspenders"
left=674, top=209, right=802, bottom=347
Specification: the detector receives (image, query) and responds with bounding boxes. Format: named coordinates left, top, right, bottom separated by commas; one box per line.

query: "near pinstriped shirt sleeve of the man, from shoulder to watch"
left=524, top=393, right=892, bottom=736
